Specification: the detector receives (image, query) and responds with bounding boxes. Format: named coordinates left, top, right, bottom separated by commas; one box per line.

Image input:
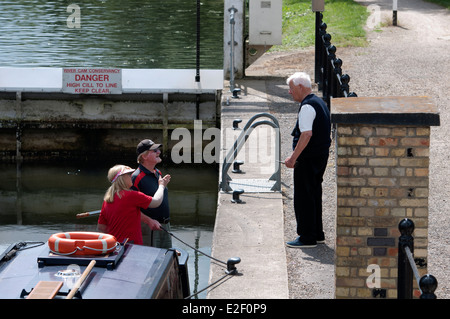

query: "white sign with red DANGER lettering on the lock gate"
left=63, top=68, right=122, bottom=94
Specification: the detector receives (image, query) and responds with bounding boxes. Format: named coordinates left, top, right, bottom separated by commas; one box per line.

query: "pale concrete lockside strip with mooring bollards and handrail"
left=208, top=79, right=289, bottom=299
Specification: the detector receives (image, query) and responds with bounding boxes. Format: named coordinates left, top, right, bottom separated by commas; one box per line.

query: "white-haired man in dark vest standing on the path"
left=285, top=72, right=331, bottom=248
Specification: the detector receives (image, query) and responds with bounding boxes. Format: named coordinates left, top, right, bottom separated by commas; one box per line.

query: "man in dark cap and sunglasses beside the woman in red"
left=131, top=139, right=172, bottom=248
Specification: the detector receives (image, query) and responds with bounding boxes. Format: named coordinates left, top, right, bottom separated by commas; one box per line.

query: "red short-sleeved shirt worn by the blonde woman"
left=98, top=190, right=152, bottom=245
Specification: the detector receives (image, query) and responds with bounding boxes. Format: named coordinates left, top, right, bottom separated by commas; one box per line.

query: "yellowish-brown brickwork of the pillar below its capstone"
left=336, top=125, right=430, bottom=298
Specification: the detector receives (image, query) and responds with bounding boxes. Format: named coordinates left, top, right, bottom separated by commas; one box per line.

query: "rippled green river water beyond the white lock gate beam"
left=0, top=0, right=223, bottom=69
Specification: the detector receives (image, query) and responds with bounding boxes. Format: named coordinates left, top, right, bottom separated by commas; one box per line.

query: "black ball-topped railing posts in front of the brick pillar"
left=397, top=218, right=437, bottom=299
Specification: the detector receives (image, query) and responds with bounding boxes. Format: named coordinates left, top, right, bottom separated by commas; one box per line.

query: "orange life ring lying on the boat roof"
left=48, top=232, right=117, bottom=255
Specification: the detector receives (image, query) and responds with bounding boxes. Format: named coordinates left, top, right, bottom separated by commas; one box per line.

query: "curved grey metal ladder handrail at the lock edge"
left=220, top=113, right=281, bottom=192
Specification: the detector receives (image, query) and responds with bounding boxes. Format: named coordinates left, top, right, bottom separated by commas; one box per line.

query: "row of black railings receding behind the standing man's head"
left=314, top=12, right=357, bottom=108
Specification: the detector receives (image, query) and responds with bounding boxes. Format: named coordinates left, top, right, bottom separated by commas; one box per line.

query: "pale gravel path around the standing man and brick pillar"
left=246, top=0, right=450, bottom=298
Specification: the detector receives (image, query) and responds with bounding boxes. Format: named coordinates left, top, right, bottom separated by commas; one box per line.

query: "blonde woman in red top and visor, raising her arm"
left=97, top=165, right=170, bottom=245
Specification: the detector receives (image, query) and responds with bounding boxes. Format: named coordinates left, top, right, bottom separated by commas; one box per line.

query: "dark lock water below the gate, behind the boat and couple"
left=0, top=163, right=218, bottom=298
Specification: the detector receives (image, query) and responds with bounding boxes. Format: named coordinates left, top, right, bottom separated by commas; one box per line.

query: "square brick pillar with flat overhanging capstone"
left=331, top=97, right=439, bottom=298
